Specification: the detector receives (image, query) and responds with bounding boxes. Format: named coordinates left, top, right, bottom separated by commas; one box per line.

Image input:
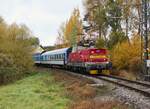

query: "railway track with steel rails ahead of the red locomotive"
left=92, top=75, right=150, bottom=97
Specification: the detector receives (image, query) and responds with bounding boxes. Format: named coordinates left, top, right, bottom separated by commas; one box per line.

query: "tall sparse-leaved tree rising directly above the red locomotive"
left=84, top=0, right=108, bottom=47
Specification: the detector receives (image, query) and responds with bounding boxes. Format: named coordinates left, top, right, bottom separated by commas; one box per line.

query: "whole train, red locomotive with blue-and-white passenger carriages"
left=33, top=47, right=112, bottom=74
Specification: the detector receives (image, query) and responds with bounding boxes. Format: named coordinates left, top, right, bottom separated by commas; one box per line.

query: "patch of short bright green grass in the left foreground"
left=0, top=73, right=69, bottom=109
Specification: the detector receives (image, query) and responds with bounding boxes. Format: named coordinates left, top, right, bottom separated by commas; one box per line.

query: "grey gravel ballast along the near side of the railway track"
left=93, top=77, right=150, bottom=109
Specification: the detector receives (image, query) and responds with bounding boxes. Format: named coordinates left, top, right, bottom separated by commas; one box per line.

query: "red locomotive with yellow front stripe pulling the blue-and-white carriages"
left=67, top=48, right=111, bottom=74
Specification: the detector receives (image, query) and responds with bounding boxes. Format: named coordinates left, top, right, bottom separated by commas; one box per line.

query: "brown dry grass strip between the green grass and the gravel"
left=47, top=70, right=131, bottom=109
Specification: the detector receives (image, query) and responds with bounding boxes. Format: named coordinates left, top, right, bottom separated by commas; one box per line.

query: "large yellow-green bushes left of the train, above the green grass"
left=0, top=17, right=39, bottom=84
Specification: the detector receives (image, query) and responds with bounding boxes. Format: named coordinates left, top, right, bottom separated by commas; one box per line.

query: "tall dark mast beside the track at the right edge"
left=141, top=0, right=150, bottom=81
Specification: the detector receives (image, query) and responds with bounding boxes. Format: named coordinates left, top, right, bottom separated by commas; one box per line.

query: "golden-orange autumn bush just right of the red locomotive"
left=111, top=35, right=141, bottom=71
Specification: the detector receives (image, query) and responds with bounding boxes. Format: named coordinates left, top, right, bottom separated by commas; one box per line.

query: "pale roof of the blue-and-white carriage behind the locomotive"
left=42, top=48, right=69, bottom=55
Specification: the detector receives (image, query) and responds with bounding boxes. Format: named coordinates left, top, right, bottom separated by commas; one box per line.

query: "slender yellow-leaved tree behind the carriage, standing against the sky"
left=56, top=9, right=83, bottom=48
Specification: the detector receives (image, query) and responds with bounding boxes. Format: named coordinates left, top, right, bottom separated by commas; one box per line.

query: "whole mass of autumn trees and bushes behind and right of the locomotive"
left=56, top=0, right=144, bottom=74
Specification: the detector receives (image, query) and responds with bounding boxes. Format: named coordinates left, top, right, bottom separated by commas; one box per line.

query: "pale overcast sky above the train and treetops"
left=0, top=0, right=83, bottom=46
